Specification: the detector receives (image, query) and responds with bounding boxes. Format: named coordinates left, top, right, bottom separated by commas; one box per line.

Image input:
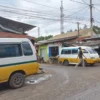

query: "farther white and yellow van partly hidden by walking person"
left=59, top=46, right=99, bottom=65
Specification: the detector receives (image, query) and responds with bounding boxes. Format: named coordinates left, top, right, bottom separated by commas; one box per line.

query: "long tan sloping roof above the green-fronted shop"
left=37, top=29, right=94, bottom=45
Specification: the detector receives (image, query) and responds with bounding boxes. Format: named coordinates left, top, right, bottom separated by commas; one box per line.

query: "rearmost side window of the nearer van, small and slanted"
left=22, top=42, right=33, bottom=56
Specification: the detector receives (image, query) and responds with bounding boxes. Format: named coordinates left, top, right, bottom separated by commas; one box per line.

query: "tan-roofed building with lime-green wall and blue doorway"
left=37, top=29, right=95, bottom=61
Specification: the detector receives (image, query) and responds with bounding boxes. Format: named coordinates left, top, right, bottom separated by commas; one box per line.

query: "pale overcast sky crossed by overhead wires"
left=0, top=0, right=100, bottom=37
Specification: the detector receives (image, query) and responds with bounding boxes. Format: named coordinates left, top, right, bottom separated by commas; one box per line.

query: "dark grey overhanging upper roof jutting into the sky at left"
left=0, top=17, right=36, bottom=34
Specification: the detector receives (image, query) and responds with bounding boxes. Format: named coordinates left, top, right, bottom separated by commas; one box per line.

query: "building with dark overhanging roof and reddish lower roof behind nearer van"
left=0, top=17, right=36, bottom=41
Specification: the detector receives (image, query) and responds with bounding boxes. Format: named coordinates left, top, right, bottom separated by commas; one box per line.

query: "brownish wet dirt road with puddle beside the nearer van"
left=0, top=64, right=100, bottom=100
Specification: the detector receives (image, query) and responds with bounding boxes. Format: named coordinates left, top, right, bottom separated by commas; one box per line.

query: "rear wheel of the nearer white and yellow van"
left=8, top=72, right=25, bottom=89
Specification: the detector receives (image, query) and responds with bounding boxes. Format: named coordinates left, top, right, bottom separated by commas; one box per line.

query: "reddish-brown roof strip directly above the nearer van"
left=0, top=32, right=35, bottom=40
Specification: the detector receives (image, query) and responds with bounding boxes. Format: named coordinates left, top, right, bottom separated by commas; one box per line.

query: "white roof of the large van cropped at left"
left=0, top=38, right=30, bottom=42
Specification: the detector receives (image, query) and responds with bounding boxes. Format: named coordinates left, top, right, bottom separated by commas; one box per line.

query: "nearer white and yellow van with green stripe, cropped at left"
left=0, top=38, right=39, bottom=88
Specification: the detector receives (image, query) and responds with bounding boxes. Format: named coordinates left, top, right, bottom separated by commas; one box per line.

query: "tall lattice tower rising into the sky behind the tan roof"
left=60, top=0, right=64, bottom=34
